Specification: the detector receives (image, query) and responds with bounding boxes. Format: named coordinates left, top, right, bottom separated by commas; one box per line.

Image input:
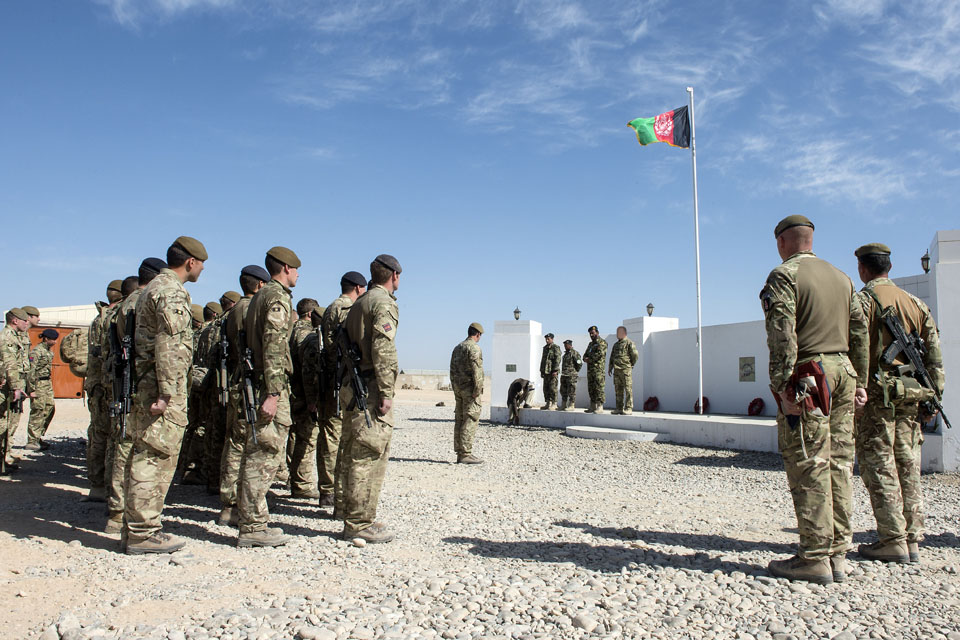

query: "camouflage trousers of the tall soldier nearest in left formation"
left=124, top=400, right=185, bottom=543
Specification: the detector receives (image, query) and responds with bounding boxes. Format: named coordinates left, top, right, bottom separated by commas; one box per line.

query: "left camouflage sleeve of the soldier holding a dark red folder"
left=760, top=270, right=797, bottom=393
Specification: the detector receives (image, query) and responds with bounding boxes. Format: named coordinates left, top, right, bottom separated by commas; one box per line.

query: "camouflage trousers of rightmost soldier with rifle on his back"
left=856, top=398, right=923, bottom=544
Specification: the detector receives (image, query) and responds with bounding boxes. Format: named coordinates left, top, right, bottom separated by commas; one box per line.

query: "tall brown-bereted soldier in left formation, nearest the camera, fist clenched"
left=121, top=236, right=207, bottom=554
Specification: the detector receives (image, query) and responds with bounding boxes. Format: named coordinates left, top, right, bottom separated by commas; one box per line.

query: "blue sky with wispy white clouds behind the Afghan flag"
left=0, top=0, right=960, bottom=368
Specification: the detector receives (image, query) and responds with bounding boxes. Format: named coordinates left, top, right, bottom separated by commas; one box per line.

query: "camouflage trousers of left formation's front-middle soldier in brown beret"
left=237, top=390, right=291, bottom=533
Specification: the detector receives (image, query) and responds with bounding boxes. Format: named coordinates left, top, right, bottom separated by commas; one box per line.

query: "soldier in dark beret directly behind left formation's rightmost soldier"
left=317, top=271, right=367, bottom=519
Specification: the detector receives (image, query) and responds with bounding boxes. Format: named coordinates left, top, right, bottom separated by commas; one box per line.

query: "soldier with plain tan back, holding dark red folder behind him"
left=760, top=215, right=868, bottom=584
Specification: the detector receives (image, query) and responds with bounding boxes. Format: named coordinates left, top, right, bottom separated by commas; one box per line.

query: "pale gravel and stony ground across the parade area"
left=0, top=392, right=960, bottom=640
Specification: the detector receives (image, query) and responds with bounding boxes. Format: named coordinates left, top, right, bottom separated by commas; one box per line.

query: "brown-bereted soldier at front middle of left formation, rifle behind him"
left=237, top=247, right=300, bottom=547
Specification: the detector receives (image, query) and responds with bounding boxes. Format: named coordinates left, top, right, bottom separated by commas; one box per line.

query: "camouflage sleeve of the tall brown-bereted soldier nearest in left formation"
left=154, top=293, right=193, bottom=396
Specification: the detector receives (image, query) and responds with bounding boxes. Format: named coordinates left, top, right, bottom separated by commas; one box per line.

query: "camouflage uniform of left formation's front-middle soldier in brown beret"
left=237, top=280, right=293, bottom=535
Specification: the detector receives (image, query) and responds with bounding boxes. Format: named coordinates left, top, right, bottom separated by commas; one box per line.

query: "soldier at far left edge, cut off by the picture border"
left=0, top=307, right=30, bottom=475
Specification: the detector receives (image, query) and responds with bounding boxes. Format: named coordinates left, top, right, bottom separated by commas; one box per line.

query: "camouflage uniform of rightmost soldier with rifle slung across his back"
left=856, top=278, right=944, bottom=545
